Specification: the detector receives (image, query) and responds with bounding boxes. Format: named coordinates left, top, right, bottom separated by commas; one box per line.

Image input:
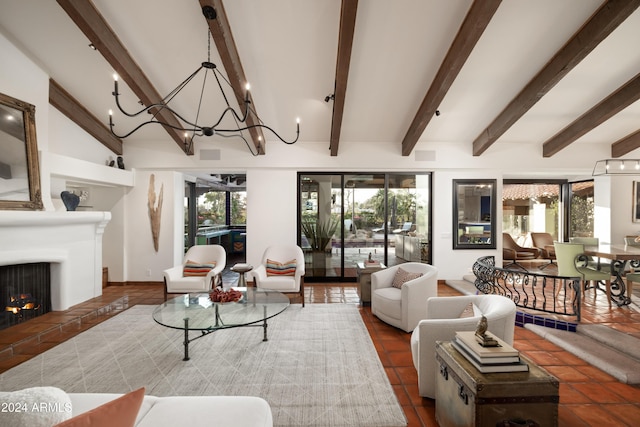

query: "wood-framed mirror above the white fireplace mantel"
left=0, top=93, right=43, bottom=210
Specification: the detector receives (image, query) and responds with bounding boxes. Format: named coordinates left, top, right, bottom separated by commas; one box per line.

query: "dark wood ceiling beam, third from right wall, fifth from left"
left=402, top=0, right=502, bottom=156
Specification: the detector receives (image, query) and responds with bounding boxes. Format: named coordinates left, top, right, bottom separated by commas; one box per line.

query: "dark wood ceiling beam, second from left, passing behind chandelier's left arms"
left=57, top=0, right=193, bottom=155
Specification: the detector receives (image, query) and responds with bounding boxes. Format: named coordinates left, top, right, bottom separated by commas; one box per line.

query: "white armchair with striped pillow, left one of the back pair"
left=162, top=245, right=227, bottom=301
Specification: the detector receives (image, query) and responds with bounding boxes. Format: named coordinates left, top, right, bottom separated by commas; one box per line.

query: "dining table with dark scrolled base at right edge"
left=584, top=244, right=640, bottom=307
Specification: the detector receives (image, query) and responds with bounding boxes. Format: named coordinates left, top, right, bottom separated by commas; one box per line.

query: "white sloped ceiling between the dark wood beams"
left=0, top=0, right=640, bottom=160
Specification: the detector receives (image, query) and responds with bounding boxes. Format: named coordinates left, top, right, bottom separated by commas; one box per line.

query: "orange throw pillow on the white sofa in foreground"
left=55, top=387, right=144, bottom=427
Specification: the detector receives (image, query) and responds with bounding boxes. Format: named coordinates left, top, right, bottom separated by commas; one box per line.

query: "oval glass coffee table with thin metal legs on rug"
left=153, top=287, right=289, bottom=360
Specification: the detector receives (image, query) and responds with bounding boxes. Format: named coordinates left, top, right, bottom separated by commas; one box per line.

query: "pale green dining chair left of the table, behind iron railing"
left=553, top=242, right=611, bottom=308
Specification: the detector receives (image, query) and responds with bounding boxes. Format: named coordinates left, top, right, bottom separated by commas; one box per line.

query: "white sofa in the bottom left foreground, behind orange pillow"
left=69, top=393, right=273, bottom=427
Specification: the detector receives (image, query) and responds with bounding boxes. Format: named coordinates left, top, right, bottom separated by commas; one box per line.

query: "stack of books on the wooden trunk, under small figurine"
left=453, top=331, right=529, bottom=373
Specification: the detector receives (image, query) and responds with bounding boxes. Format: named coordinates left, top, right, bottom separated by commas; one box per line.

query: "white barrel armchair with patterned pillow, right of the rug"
left=371, top=262, right=438, bottom=332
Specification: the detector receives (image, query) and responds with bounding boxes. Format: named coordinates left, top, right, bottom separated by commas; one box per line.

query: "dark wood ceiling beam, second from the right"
left=542, top=74, right=640, bottom=157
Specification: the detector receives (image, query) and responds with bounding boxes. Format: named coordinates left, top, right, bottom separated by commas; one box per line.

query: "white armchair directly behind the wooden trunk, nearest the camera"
left=411, top=295, right=516, bottom=399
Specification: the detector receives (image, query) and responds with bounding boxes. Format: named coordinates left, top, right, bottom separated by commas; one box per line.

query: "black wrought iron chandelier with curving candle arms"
left=109, top=9, right=300, bottom=156
